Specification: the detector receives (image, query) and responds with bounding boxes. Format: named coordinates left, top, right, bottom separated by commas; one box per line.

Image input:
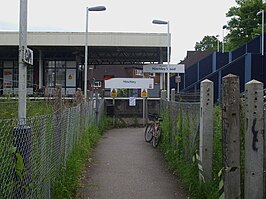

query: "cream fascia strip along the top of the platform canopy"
left=0, top=31, right=171, bottom=47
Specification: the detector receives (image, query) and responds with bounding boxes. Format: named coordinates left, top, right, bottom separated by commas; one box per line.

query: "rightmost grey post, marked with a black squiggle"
left=245, top=80, right=264, bottom=199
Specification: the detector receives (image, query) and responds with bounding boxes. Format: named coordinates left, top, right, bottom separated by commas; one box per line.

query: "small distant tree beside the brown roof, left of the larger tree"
left=195, top=36, right=218, bottom=51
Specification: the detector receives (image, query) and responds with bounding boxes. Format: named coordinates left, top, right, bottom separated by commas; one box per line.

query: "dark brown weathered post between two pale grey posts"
left=222, top=74, right=241, bottom=199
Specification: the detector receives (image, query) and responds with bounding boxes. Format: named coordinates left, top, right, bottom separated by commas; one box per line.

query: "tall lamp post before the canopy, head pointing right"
left=84, top=6, right=106, bottom=100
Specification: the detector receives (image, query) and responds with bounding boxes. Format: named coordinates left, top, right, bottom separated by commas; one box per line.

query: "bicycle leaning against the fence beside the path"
left=144, top=113, right=162, bottom=148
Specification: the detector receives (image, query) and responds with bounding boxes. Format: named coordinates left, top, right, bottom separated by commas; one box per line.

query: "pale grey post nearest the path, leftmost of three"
left=199, top=79, right=213, bottom=181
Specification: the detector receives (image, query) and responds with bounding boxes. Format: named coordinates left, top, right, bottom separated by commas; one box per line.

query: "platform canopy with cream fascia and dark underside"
left=0, top=32, right=170, bottom=65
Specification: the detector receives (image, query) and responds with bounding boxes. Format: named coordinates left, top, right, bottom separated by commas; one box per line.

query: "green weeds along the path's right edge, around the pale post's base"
left=160, top=107, right=222, bottom=199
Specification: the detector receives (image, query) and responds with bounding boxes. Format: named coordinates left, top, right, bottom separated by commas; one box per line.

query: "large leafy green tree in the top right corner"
left=225, top=0, right=266, bottom=51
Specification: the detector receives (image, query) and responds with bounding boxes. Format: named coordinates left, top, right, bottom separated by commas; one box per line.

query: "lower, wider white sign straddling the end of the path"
left=104, top=78, right=154, bottom=89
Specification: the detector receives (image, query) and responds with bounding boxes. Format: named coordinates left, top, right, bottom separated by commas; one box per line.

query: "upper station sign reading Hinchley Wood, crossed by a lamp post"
left=143, top=64, right=185, bottom=73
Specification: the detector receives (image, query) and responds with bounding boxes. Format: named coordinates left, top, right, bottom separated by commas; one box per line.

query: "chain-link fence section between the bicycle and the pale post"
left=160, top=94, right=200, bottom=159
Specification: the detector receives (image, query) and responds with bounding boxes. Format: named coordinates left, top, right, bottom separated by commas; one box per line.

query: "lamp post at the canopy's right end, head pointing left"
left=152, top=19, right=170, bottom=100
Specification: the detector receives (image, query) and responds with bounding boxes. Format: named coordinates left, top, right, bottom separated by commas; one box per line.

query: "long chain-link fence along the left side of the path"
left=0, top=100, right=104, bottom=198
